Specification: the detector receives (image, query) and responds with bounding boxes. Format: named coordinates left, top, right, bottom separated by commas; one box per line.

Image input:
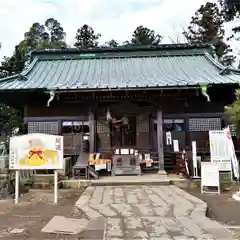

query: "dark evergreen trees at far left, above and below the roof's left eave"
left=0, top=18, right=66, bottom=136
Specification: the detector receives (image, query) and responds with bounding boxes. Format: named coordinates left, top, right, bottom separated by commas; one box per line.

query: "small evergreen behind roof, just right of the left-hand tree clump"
left=74, top=24, right=101, bottom=48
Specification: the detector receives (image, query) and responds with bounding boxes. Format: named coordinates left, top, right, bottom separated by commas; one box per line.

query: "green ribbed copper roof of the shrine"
left=0, top=44, right=240, bottom=90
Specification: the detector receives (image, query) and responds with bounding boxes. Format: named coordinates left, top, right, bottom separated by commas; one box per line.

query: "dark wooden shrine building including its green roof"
left=0, top=44, right=240, bottom=174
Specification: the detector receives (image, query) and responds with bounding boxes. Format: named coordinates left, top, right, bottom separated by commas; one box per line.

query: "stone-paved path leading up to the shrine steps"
left=76, top=185, right=235, bottom=240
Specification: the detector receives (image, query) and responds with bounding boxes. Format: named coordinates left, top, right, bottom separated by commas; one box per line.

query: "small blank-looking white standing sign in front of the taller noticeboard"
left=201, top=162, right=220, bottom=194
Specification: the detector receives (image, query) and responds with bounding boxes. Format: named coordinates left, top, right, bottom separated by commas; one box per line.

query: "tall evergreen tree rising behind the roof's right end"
left=183, top=2, right=235, bottom=65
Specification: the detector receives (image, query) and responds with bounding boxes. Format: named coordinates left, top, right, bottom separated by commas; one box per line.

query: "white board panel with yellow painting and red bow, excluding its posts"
left=9, top=133, right=64, bottom=170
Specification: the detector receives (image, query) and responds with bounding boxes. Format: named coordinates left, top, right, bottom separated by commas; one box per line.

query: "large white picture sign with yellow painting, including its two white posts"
left=9, top=133, right=64, bottom=204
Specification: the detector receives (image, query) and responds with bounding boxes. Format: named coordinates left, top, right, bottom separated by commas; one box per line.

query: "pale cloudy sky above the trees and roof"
left=0, top=0, right=238, bottom=59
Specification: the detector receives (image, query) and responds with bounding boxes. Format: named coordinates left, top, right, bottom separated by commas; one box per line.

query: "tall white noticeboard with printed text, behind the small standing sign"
left=209, top=130, right=232, bottom=171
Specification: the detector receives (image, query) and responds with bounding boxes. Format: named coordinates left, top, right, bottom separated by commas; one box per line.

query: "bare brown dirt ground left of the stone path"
left=0, top=189, right=83, bottom=240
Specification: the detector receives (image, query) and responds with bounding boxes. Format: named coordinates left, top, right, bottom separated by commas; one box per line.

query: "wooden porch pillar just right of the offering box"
left=157, top=109, right=166, bottom=174
